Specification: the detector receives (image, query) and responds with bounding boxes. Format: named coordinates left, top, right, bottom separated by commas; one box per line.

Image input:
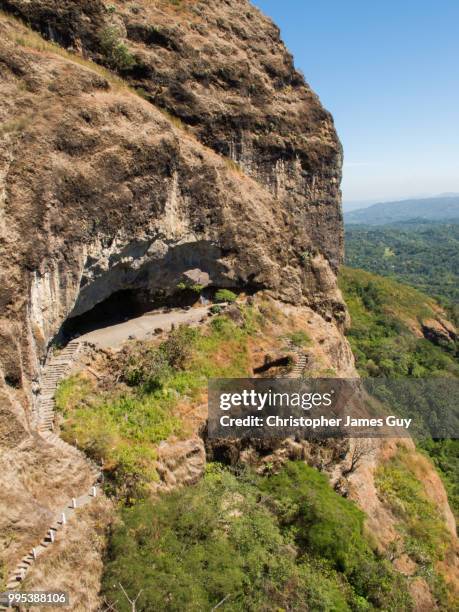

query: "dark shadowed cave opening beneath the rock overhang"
left=54, top=241, right=263, bottom=345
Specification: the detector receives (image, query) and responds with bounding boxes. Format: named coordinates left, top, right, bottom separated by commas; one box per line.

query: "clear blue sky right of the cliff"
left=254, top=0, right=459, bottom=206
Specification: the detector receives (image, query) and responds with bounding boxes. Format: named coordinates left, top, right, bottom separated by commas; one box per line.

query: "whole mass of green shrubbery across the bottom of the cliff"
left=103, top=463, right=411, bottom=612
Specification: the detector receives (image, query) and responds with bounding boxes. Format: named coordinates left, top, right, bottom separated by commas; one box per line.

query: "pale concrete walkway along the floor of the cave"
left=78, top=306, right=210, bottom=349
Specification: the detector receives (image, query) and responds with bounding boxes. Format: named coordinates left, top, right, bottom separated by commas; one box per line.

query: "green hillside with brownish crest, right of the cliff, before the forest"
left=340, top=267, right=459, bottom=517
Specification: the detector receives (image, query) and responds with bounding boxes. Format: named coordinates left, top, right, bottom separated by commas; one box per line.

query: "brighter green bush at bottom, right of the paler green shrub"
left=260, top=462, right=410, bottom=610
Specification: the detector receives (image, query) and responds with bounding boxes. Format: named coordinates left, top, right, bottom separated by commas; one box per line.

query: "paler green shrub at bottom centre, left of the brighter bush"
left=103, top=474, right=293, bottom=611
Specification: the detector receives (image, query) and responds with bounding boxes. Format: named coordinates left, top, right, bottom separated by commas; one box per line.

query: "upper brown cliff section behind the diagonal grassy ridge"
left=3, top=0, right=343, bottom=270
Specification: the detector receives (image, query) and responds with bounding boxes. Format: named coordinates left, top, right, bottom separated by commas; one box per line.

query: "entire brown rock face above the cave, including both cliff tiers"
left=0, top=0, right=345, bottom=404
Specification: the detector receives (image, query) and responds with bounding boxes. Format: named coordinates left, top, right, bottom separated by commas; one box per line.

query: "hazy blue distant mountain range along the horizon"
left=344, top=195, right=459, bottom=225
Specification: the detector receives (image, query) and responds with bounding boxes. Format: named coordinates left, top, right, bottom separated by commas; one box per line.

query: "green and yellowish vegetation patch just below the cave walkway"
left=56, top=309, right=256, bottom=501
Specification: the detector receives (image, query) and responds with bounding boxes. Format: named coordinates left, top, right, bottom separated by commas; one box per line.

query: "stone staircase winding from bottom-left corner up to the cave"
left=0, top=340, right=102, bottom=610
